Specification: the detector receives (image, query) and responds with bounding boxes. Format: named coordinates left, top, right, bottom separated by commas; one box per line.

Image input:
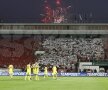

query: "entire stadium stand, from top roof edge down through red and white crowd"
left=0, top=23, right=108, bottom=72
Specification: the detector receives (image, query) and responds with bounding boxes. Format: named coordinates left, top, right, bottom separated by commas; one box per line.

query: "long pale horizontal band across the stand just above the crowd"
left=0, top=30, right=108, bottom=34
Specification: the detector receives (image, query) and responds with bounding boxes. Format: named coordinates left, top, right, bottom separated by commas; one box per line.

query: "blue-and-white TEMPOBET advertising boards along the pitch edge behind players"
left=0, top=72, right=108, bottom=77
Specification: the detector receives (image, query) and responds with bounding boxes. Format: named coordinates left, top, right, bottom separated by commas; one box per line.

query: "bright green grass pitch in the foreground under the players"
left=0, top=76, right=108, bottom=90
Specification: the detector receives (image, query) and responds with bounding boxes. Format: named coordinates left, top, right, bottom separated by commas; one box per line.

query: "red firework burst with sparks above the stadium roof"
left=41, top=0, right=69, bottom=23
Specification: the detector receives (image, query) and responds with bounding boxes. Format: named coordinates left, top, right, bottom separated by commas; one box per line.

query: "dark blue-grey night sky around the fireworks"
left=0, top=0, right=108, bottom=23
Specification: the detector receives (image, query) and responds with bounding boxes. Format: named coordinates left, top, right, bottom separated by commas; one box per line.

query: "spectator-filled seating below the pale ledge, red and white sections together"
left=0, top=35, right=105, bottom=72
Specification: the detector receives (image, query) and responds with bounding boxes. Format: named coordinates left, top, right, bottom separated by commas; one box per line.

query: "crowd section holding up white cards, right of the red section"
left=39, top=36, right=104, bottom=72
